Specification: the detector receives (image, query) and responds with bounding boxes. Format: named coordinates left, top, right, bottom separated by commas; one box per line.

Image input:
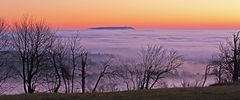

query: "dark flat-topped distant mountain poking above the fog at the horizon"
left=88, top=26, right=134, bottom=30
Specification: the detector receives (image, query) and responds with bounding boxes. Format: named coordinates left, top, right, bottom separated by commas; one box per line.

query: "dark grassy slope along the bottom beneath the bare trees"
left=0, top=86, right=240, bottom=100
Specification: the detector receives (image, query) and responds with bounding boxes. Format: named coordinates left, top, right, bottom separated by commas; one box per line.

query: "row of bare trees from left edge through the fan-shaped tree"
left=0, top=16, right=183, bottom=93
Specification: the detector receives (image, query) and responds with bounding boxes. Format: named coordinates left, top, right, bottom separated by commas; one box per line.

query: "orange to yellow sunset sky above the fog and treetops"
left=0, top=0, right=240, bottom=28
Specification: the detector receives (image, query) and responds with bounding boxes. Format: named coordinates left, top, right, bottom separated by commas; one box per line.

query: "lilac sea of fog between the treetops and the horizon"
left=56, top=29, right=237, bottom=73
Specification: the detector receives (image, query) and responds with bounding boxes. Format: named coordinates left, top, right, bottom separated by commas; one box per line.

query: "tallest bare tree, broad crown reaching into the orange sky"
left=12, top=17, right=54, bottom=93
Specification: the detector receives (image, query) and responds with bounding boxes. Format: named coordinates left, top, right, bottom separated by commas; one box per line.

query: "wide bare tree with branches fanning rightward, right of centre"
left=139, top=45, right=183, bottom=89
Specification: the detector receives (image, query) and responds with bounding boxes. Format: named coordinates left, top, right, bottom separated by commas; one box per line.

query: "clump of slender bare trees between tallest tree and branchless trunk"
left=47, top=35, right=82, bottom=93
